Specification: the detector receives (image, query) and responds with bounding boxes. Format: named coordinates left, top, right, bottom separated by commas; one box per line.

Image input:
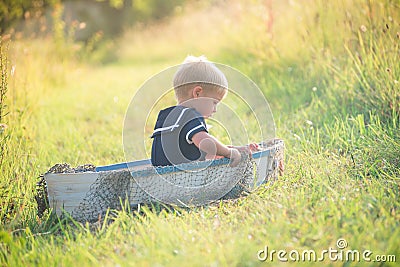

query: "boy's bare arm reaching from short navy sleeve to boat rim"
left=192, top=131, right=242, bottom=167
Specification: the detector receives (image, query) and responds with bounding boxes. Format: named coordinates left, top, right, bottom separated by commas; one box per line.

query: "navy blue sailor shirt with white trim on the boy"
left=151, top=105, right=208, bottom=166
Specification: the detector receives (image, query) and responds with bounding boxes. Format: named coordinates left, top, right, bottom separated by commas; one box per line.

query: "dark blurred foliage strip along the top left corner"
left=0, top=0, right=186, bottom=41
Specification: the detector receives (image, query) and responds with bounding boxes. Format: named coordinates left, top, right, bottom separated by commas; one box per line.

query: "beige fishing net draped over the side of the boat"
left=36, top=139, right=283, bottom=222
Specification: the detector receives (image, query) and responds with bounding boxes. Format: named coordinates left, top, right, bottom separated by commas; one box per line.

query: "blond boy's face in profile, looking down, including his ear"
left=184, top=87, right=226, bottom=118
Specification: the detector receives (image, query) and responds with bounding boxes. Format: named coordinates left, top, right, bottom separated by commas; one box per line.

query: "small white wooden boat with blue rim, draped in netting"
left=44, top=139, right=284, bottom=221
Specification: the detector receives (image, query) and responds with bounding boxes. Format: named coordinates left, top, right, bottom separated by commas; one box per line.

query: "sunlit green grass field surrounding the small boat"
left=0, top=0, right=400, bottom=266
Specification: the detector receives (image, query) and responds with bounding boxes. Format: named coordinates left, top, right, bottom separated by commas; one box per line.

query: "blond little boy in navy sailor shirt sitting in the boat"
left=151, top=56, right=257, bottom=167
